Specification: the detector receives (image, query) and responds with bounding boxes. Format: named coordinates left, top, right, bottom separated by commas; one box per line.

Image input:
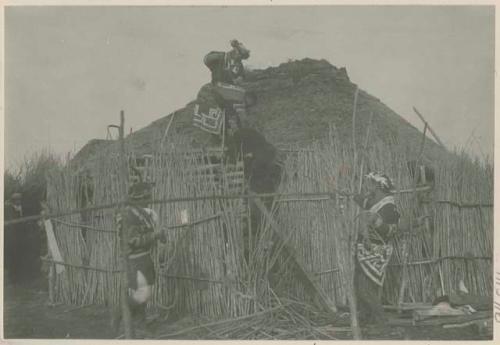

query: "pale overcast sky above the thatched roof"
left=5, top=6, right=494, bottom=166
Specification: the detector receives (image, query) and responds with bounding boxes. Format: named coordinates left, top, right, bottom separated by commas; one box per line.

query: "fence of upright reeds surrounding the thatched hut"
left=48, top=135, right=493, bottom=322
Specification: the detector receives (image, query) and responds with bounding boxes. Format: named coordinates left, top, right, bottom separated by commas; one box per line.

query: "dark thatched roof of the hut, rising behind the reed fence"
left=75, top=59, right=444, bottom=168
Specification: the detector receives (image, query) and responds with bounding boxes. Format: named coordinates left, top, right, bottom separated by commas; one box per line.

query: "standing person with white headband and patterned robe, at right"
left=354, top=172, right=400, bottom=324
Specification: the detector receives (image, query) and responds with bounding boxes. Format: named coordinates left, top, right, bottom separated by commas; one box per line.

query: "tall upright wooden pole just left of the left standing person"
left=119, top=110, right=134, bottom=339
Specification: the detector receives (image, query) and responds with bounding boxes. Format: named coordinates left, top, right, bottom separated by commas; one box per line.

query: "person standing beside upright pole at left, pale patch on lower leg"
left=112, top=181, right=165, bottom=331
